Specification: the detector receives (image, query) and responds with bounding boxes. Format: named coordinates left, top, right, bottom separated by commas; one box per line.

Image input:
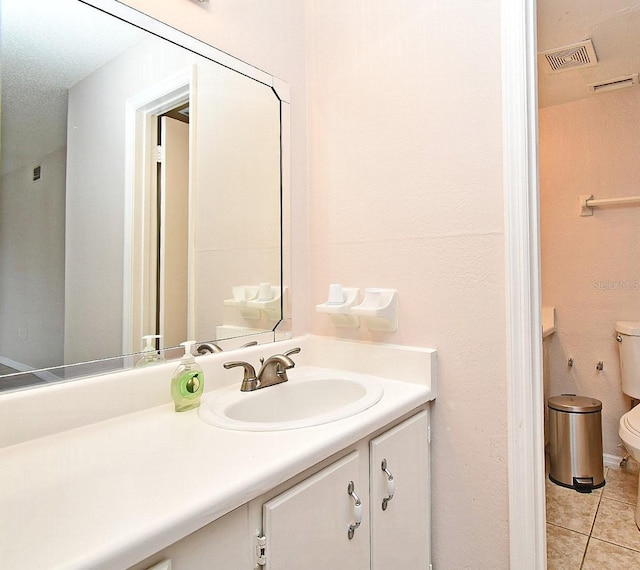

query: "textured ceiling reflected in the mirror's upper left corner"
left=0, top=0, right=142, bottom=173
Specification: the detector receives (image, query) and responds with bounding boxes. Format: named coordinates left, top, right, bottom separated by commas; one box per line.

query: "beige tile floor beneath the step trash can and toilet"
left=546, top=461, right=640, bottom=570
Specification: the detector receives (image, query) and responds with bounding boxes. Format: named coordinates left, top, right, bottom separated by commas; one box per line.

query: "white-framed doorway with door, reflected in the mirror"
left=123, top=66, right=196, bottom=354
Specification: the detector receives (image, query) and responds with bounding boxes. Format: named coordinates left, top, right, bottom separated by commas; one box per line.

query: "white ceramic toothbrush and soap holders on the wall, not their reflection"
left=316, top=283, right=398, bottom=332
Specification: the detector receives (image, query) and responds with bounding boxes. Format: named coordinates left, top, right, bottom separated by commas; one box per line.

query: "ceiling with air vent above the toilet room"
left=538, top=0, right=640, bottom=107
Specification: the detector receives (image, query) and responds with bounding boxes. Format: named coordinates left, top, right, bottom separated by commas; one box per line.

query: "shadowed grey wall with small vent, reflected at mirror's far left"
left=0, top=147, right=66, bottom=369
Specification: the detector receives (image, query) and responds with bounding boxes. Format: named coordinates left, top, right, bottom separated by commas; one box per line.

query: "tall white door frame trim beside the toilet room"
left=501, top=0, right=546, bottom=570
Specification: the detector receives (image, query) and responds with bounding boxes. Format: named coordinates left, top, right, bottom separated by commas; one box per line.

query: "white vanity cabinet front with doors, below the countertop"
left=133, top=410, right=430, bottom=570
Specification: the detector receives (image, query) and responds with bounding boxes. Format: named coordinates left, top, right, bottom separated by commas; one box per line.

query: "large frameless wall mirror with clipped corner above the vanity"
left=0, top=0, right=288, bottom=391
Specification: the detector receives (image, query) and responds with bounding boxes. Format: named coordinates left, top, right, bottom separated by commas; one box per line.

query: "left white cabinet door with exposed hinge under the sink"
left=263, top=451, right=369, bottom=570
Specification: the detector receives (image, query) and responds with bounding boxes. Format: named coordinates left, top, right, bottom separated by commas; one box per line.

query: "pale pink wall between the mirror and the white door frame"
left=121, top=0, right=509, bottom=570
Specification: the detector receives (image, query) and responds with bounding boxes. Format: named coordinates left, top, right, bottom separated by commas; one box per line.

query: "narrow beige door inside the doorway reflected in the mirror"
left=155, top=116, right=189, bottom=346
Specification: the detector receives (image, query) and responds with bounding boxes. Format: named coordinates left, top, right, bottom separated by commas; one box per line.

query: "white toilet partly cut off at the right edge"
left=616, top=321, right=640, bottom=528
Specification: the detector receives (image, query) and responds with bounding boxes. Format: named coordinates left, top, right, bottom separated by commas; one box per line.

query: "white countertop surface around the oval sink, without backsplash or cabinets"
left=0, top=338, right=435, bottom=570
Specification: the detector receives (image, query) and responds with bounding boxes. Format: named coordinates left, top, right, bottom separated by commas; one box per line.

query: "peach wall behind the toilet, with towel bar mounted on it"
left=539, top=85, right=640, bottom=456
